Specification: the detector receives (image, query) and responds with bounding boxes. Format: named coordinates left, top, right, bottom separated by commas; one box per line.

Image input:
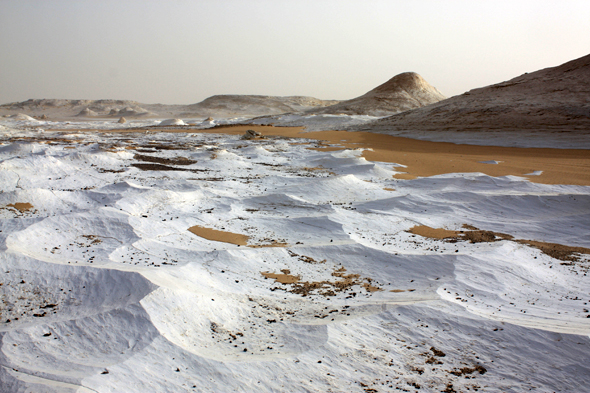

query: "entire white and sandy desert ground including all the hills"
left=0, top=48, right=590, bottom=393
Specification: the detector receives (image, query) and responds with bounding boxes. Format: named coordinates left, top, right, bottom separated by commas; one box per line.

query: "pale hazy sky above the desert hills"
left=0, top=0, right=590, bottom=104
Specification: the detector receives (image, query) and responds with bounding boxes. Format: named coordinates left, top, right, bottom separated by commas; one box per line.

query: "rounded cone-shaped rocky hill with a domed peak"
left=310, top=72, right=446, bottom=116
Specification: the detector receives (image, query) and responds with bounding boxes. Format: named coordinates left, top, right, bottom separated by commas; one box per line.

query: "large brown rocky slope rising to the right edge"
left=362, top=55, right=590, bottom=132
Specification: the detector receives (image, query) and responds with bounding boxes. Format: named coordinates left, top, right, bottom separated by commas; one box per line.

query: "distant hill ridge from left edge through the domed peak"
left=0, top=72, right=445, bottom=118
